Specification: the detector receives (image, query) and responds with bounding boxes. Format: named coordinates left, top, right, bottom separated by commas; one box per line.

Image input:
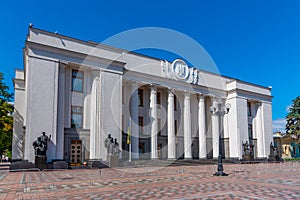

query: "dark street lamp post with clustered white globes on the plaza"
left=210, top=99, right=231, bottom=176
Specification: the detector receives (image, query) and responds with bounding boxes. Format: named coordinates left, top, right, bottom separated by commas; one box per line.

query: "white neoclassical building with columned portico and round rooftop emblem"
left=13, top=28, right=272, bottom=163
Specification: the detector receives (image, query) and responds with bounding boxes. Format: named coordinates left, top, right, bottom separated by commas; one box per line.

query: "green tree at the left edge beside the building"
left=0, top=72, right=14, bottom=158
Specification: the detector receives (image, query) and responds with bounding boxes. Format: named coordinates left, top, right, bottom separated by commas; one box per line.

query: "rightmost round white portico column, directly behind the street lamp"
left=211, top=98, right=220, bottom=159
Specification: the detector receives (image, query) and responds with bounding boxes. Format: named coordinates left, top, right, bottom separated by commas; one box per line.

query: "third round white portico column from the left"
left=168, top=90, right=176, bottom=160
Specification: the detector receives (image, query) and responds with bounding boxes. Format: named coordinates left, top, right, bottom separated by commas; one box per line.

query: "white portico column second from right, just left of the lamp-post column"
left=198, top=95, right=207, bottom=159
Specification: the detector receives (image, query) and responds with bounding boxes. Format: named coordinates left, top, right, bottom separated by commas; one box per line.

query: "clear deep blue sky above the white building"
left=0, top=0, right=300, bottom=130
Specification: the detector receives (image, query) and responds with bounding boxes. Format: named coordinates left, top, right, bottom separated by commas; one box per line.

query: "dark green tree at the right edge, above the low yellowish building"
left=285, top=96, right=300, bottom=138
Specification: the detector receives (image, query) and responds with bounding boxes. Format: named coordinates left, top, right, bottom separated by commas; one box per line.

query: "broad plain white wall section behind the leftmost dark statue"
left=24, top=58, right=59, bottom=162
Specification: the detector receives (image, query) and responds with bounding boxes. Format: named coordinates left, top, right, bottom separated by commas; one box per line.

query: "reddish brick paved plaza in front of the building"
left=0, top=162, right=300, bottom=199
